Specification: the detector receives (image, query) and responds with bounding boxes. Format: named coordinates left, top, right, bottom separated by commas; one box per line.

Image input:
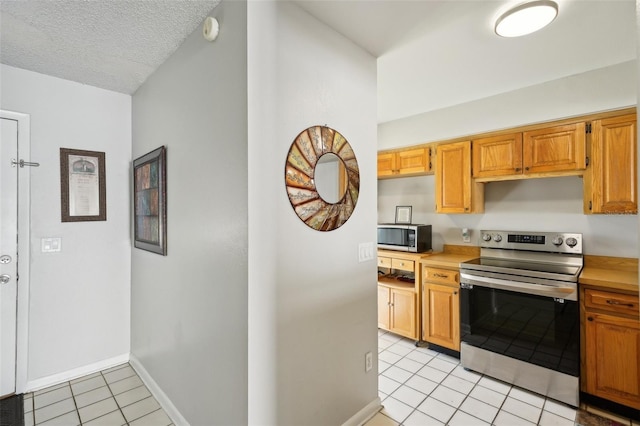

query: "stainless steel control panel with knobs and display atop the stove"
left=480, top=231, right=582, bottom=254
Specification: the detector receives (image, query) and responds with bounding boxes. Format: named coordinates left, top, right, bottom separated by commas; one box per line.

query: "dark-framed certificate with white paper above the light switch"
left=60, top=148, right=107, bottom=222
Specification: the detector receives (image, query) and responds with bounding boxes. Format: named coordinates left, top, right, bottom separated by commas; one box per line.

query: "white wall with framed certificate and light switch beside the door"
left=1, top=65, right=131, bottom=389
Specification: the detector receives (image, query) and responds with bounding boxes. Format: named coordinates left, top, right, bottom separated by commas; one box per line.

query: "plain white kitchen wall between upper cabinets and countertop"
left=378, top=176, right=638, bottom=257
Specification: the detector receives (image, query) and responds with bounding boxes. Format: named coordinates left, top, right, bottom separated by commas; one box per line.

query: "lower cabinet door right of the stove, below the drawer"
left=585, top=312, right=640, bottom=409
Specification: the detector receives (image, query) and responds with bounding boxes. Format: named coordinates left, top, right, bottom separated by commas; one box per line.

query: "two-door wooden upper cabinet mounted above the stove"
left=473, top=122, right=586, bottom=181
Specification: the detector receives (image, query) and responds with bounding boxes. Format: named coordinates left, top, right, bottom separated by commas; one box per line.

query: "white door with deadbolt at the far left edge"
left=0, top=117, right=18, bottom=397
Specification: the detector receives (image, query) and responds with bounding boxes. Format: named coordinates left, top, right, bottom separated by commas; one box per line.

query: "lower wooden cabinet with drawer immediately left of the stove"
left=422, top=266, right=460, bottom=351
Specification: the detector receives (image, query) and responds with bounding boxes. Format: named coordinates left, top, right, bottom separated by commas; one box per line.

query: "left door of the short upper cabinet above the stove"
left=472, top=133, right=522, bottom=177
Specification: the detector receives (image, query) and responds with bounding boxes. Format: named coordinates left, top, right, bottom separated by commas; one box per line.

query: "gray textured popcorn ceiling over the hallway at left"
left=0, top=0, right=220, bottom=94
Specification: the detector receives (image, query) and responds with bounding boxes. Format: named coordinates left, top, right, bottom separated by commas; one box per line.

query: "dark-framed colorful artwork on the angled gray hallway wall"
left=133, top=146, right=167, bottom=256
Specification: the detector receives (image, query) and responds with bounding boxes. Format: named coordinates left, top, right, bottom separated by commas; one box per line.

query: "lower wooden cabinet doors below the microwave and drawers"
left=378, top=285, right=418, bottom=340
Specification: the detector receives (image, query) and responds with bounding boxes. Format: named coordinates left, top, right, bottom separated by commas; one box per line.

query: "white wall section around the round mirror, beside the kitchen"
left=248, top=2, right=378, bottom=425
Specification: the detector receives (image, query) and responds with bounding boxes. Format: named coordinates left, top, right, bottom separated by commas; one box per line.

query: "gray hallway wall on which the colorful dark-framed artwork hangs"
left=131, top=1, right=248, bottom=425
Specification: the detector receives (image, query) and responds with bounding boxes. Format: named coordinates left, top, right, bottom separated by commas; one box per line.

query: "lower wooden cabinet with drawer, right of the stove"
left=582, top=288, right=640, bottom=409
